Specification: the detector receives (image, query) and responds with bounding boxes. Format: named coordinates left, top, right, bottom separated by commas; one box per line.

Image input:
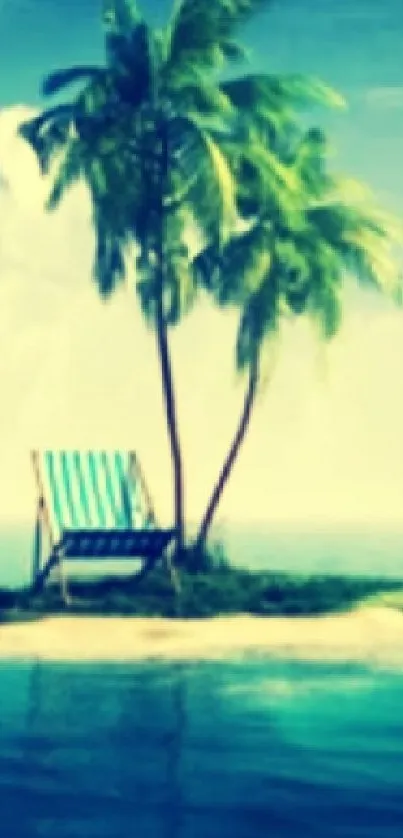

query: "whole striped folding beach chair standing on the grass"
left=32, top=451, right=175, bottom=599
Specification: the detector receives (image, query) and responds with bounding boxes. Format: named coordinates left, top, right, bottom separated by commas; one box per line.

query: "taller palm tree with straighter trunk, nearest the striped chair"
left=21, top=0, right=344, bottom=554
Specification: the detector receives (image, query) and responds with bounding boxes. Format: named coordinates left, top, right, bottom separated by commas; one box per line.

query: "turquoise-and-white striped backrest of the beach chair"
left=33, top=451, right=154, bottom=540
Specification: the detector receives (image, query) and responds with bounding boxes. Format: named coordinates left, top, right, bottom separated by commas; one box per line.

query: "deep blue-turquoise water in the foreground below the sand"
left=0, top=658, right=403, bottom=838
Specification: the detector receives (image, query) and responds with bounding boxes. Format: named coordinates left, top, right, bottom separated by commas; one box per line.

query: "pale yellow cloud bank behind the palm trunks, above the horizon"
left=0, top=109, right=403, bottom=540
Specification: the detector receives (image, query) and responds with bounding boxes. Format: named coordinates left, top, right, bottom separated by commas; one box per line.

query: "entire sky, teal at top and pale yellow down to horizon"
left=0, top=0, right=403, bottom=525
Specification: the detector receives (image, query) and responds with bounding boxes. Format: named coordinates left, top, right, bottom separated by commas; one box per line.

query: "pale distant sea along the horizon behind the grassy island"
left=0, top=523, right=403, bottom=587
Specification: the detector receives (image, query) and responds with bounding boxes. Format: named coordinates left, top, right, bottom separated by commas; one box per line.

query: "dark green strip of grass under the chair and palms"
left=0, top=551, right=403, bottom=622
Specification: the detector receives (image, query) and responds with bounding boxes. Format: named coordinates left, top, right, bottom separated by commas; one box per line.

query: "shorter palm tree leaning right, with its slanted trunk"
left=194, top=129, right=402, bottom=561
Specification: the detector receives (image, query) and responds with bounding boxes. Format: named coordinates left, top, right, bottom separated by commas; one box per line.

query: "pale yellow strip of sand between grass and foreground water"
left=0, top=607, right=403, bottom=667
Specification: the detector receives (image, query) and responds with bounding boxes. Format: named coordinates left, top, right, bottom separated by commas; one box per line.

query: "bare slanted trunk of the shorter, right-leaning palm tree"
left=194, top=360, right=259, bottom=555
